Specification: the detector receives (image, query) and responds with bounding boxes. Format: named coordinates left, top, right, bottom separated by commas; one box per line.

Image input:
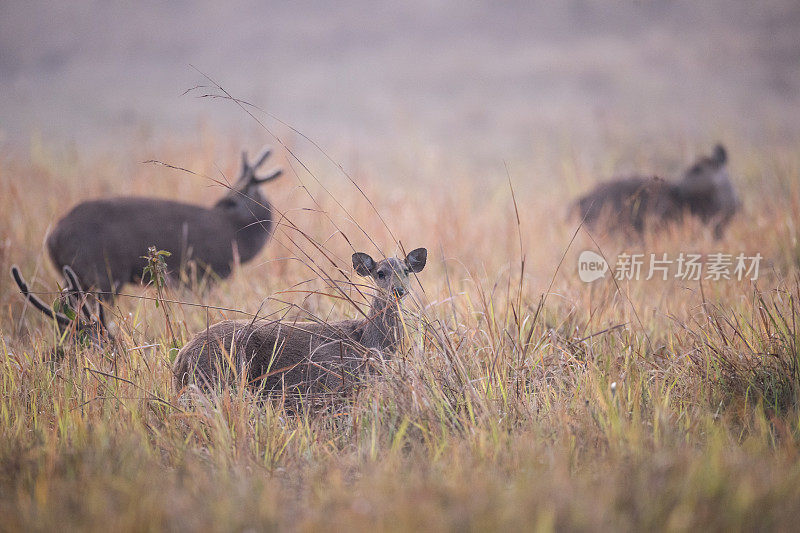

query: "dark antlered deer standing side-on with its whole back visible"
left=47, top=149, right=282, bottom=299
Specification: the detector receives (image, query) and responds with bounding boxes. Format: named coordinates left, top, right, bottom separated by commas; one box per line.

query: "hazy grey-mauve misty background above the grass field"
left=0, top=0, right=800, bottom=163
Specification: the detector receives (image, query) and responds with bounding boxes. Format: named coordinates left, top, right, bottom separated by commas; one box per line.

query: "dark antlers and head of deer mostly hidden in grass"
left=11, top=265, right=110, bottom=346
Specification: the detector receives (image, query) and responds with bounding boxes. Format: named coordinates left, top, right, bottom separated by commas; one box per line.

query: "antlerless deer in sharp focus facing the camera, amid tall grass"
left=173, top=248, right=427, bottom=393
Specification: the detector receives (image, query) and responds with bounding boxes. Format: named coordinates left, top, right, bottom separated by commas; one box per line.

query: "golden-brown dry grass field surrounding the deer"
left=0, top=135, right=800, bottom=531
